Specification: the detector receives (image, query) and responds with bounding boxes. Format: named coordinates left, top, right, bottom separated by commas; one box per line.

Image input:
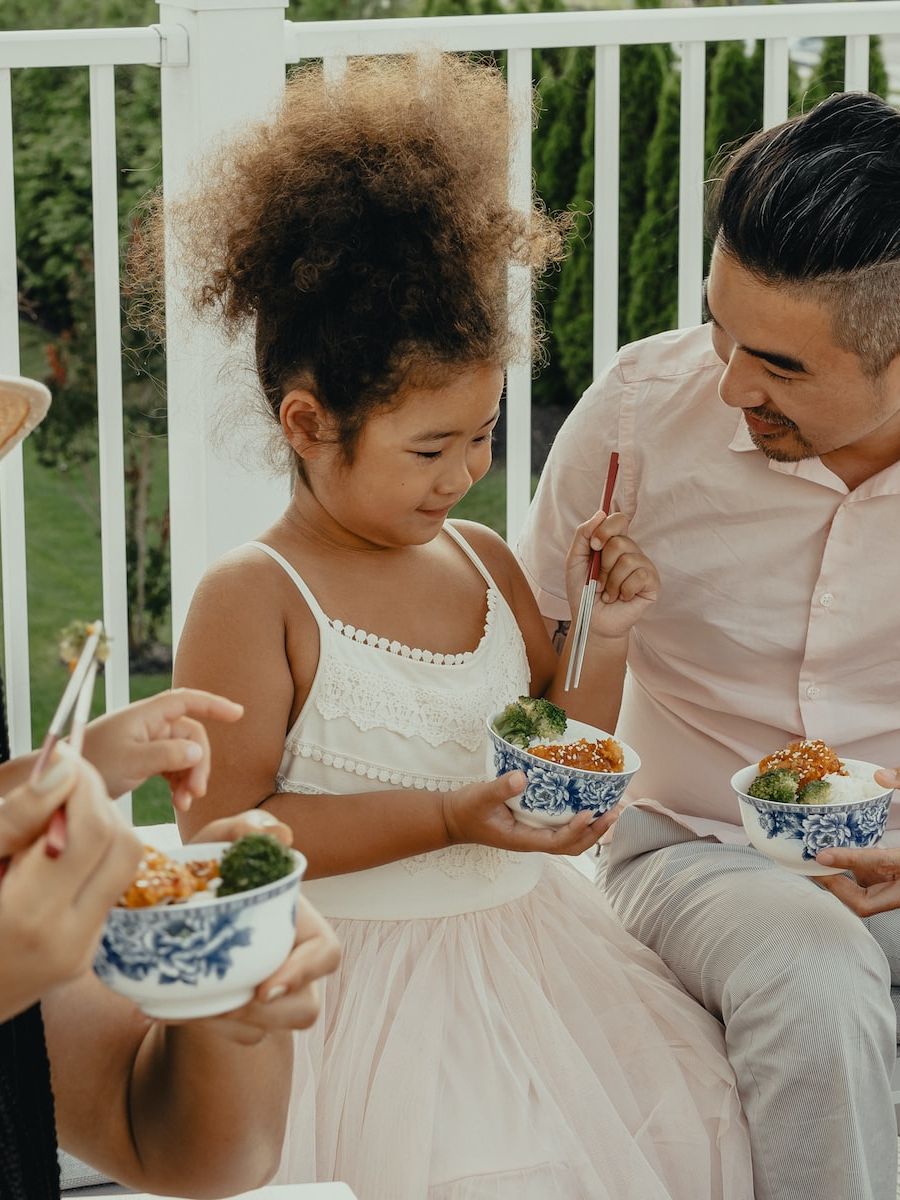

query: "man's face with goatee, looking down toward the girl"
left=707, top=246, right=900, bottom=463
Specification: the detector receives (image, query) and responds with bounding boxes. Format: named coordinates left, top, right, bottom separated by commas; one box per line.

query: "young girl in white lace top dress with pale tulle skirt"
left=164, top=51, right=752, bottom=1200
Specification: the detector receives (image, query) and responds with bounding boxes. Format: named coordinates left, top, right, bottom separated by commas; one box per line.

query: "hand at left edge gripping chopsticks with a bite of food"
left=0, top=746, right=140, bottom=1020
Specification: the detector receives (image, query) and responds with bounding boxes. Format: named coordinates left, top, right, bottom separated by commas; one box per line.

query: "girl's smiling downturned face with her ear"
left=304, top=366, right=503, bottom=547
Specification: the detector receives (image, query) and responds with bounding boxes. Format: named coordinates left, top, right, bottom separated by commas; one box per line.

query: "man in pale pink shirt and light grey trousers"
left=520, top=94, right=900, bottom=1200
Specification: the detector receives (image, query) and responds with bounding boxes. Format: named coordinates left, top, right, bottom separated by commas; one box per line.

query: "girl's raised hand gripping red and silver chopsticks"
left=565, top=512, right=660, bottom=637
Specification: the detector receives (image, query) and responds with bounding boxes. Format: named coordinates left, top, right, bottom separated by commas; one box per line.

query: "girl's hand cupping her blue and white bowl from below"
left=443, top=770, right=616, bottom=854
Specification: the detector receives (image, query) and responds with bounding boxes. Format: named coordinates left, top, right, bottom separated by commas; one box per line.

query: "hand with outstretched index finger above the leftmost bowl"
left=84, top=688, right=244, bottom=812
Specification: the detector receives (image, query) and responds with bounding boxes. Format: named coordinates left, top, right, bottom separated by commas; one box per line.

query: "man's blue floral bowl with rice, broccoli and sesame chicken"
left=731, top=739, right=893, bottom=875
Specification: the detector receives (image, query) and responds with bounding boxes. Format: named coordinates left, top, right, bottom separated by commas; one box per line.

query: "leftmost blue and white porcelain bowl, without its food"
left=94, top=841, right=306, bottom=1020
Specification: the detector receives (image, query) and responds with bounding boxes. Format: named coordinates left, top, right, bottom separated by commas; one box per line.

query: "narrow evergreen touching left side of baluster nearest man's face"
left=628, top=68, right=680, bottom=341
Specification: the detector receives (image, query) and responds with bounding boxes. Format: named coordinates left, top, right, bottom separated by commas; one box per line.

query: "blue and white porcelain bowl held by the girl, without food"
left=487, top=713, right=641, bottom=828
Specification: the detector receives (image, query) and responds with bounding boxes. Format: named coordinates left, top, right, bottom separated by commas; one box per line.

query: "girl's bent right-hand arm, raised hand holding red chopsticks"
left=456, top=512, right=659, bottom=732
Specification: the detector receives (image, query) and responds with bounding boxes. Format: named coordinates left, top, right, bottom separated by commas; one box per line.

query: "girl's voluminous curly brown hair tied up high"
left=133, top=55, right=566, bottom=460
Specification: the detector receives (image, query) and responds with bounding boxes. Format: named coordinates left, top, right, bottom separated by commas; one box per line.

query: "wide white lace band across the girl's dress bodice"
left=313, top=629, right=528, bottom=752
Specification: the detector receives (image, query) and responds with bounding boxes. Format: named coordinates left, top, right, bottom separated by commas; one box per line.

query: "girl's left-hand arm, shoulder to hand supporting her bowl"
left=175, top=551, right=605, bottom=878
